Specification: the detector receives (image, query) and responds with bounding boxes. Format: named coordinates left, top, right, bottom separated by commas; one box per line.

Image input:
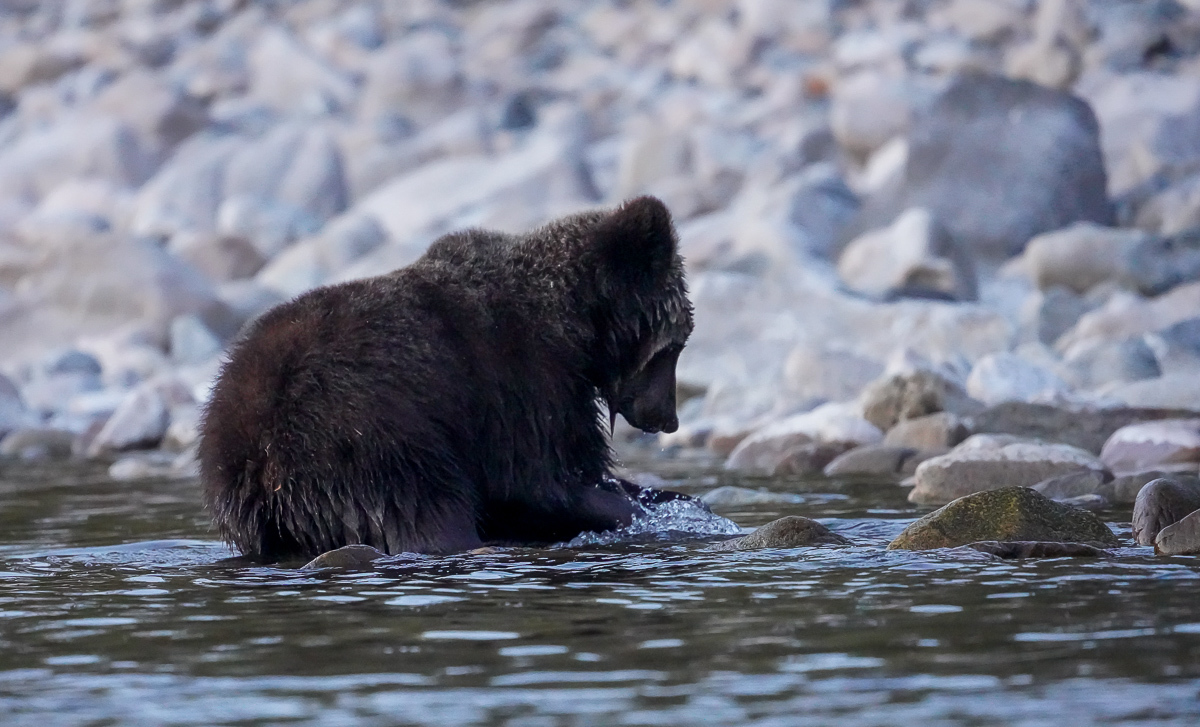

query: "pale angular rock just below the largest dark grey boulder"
left=838, top=209, right=978, bottom=300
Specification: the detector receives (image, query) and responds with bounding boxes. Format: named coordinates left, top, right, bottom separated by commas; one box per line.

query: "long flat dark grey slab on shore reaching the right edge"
left=971, top=402, right=1194, bottom=453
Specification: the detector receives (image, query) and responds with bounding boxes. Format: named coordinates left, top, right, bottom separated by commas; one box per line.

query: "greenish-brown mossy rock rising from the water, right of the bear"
left=888, top=487, right=1117, bottom=551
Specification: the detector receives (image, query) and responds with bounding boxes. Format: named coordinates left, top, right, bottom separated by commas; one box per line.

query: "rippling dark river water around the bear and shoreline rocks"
left=0, top=462, right=1200, bottom=727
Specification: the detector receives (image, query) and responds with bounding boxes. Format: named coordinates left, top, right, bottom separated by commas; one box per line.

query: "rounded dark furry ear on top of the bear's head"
left=592, top=197, right=677, bottom=282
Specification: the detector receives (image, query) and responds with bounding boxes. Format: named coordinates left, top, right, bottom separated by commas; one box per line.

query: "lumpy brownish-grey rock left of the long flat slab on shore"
left=860, top=371, right=984, bottom=432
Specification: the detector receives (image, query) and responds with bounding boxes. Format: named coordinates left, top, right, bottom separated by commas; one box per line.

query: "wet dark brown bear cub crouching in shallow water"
left=198, top=197, right=692, bottom=561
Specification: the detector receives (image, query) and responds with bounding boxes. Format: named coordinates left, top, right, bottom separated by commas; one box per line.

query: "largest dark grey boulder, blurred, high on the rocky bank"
left=859, top=76, right=1114, bottom=257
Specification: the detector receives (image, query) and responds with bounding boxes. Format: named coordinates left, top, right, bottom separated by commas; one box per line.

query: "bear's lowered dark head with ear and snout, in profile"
left=592, top=197, right=692, bottom=433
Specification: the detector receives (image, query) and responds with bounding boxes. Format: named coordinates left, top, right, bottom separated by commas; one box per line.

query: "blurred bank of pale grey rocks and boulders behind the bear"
left=0, top=0, right=1200, bottom=518
